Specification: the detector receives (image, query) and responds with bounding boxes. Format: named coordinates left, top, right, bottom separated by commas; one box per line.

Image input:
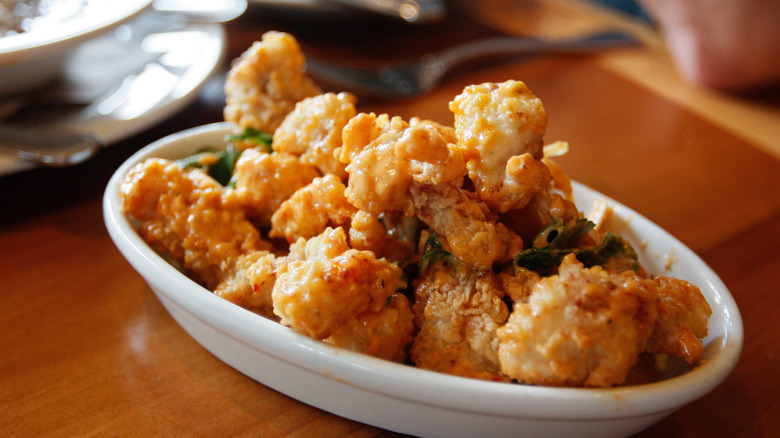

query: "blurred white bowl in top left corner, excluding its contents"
left=0, top=0, right=152, bottom=96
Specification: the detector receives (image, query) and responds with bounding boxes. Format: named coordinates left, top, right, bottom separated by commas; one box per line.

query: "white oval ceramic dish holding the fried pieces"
left=103, top=123, right=743, bottom=437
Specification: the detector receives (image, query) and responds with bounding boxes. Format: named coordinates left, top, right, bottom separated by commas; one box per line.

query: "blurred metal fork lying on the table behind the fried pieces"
left=306, top=31, right=638, bottom=99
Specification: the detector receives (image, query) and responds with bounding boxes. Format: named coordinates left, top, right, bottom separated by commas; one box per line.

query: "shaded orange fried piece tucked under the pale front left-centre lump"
left=323, top=293, right=414, bottom=362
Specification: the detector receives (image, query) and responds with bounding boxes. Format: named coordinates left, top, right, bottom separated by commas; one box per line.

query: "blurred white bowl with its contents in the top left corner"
left=0, top=0, right=151, bottom=96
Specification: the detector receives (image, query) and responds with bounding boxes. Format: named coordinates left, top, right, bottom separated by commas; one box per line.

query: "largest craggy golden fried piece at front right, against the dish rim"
left=498, top=255, right=657, bottom=387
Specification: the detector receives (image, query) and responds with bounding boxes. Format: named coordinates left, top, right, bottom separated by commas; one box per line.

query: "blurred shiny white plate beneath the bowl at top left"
left=0, top=11, right=226, bottom=176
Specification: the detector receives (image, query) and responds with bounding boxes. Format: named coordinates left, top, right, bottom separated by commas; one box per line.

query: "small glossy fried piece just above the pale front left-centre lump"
left=268, top=175, right=357, bottom=243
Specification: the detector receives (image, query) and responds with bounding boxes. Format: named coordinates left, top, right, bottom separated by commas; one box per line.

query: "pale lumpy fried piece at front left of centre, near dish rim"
left=272, top=228, right=406, bottom=339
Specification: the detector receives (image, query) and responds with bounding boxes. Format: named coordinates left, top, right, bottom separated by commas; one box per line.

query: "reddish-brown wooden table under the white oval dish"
left=0, top=0, right=780, bottom=437
